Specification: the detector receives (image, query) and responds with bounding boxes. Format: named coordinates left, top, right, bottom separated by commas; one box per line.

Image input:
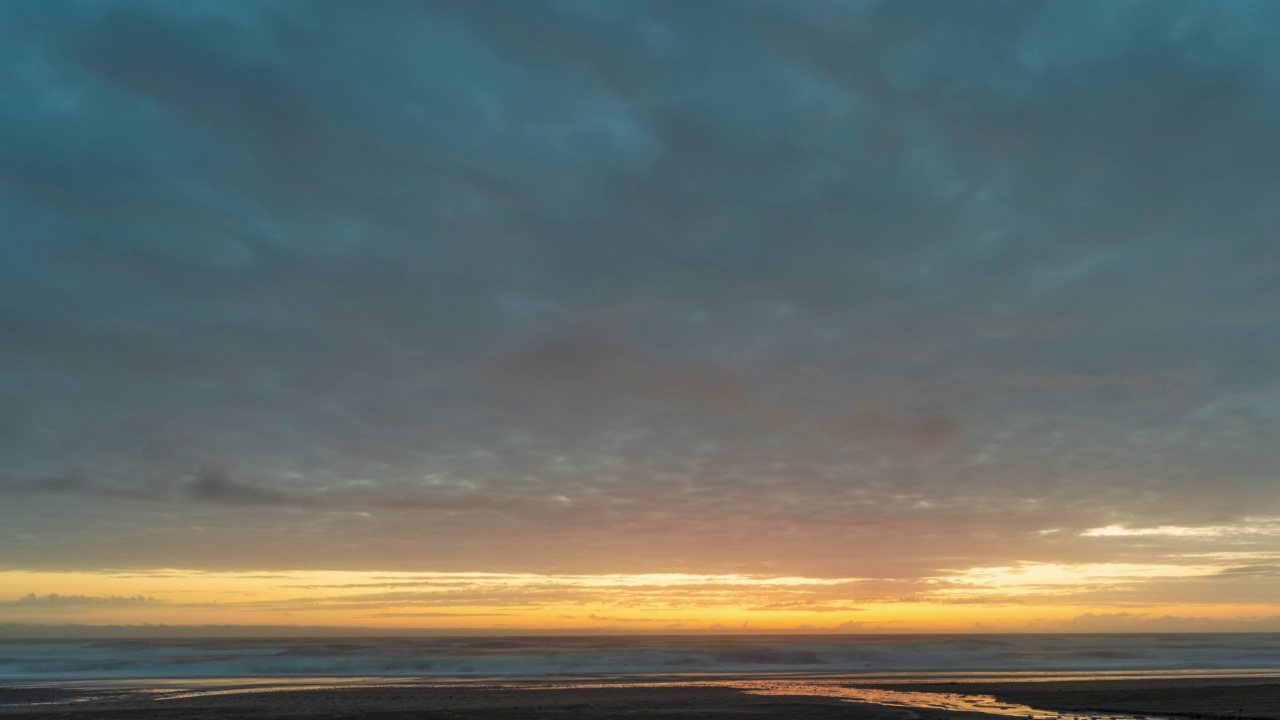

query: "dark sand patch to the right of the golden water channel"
left=867, top=678, right=1280, bottom=720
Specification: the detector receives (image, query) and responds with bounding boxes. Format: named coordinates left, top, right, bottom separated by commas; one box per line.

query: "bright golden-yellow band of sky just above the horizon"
left=0, top=559, right=1280, bottom=632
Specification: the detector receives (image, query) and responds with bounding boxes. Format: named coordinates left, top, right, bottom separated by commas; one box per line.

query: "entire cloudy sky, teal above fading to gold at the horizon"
left=0, top=0, right=1280, bottom=632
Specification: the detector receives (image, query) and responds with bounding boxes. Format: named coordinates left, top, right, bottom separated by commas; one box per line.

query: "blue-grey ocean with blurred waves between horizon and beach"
left=0, top=633, right=1280, bottom=683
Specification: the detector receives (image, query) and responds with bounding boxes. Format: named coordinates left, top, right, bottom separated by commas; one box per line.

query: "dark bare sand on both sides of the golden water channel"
left=0, top=679, right=1280, bottom=720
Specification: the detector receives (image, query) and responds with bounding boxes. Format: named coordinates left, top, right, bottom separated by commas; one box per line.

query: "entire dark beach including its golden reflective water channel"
left=0, top=678, right=1280, bottom=720
